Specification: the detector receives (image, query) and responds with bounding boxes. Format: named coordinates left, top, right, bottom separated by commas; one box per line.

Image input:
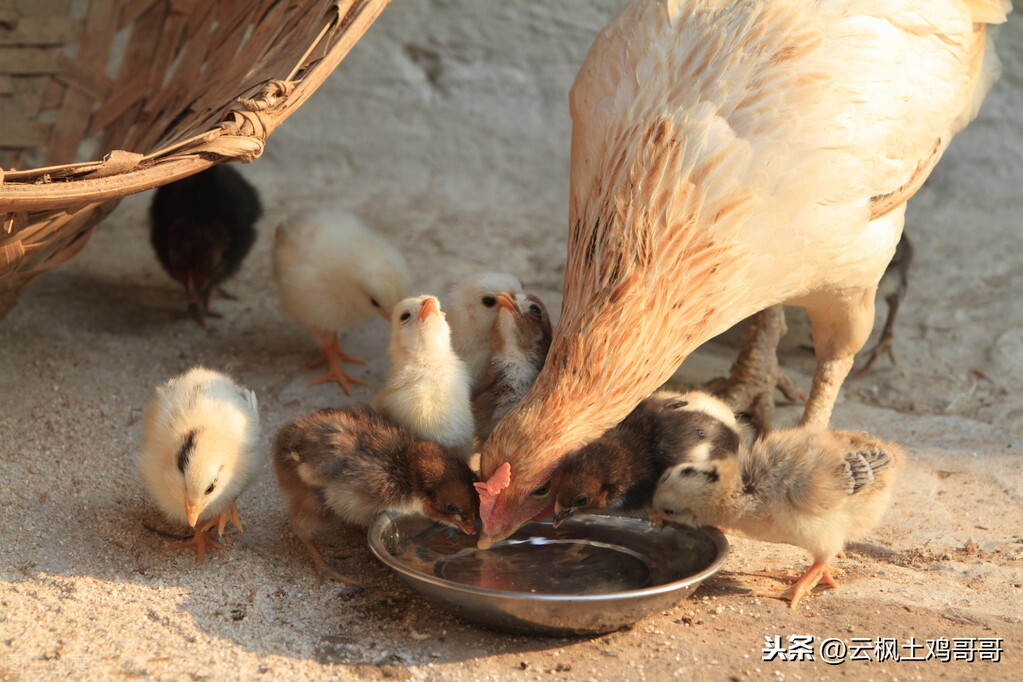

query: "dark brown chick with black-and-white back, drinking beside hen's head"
left=551, top=391, right=743, bottom=527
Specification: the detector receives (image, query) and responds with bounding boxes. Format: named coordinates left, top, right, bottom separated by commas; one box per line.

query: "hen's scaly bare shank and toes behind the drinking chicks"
left=707, top=306, right=806, bottom=434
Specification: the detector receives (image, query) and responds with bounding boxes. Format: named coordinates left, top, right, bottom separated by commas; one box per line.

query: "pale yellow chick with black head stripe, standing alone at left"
left=137, top=367, right=267, bottom=563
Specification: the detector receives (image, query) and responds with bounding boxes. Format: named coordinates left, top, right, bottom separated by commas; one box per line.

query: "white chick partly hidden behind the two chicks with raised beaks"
left=445, top=272, right=522, bottom=393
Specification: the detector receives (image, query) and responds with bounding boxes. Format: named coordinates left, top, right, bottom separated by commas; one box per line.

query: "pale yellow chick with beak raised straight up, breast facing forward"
left=371, top=295, right=473, bottom=459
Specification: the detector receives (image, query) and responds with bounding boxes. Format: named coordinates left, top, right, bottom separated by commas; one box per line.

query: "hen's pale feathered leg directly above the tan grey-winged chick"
left=801, top=287, right=877, bottom=426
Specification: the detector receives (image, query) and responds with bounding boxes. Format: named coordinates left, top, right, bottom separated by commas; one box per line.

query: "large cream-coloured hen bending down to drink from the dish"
left=481, top=0, right=1010, bottom=544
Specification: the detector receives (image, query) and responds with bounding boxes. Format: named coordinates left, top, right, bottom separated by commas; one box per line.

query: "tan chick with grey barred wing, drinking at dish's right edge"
left=651, top=427, right=903, bottom=608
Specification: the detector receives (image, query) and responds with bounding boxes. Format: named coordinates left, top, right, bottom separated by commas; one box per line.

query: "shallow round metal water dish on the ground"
left=369, top=514, right=728, bottom=635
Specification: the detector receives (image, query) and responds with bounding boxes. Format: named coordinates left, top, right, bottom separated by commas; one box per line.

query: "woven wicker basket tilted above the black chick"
left=0, top=0, right=390, bottom=317
